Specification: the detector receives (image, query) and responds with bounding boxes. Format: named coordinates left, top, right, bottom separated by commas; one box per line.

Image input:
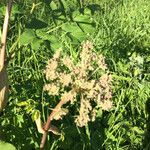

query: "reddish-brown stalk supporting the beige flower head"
left=40, top=100, right=66, bottom=150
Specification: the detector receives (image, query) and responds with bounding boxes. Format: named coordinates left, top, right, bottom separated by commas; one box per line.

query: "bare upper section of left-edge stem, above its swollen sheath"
left=0, top=0, right=13, bottom=70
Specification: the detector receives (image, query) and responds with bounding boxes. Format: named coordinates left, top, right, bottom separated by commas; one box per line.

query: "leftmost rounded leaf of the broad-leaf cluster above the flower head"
left=20, top=29, right=36, bottom=45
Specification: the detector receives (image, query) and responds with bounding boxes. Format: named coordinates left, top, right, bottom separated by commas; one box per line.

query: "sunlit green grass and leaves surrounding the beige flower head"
left=0, top=0, right=150, bottom=150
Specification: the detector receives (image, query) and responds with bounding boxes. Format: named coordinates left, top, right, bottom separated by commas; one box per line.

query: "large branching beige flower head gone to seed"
left=44, top=41, right=112, bottom=127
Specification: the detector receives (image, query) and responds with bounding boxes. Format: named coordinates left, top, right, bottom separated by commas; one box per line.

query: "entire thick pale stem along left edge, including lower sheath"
left=0, top=0, right=13, bottom=111
